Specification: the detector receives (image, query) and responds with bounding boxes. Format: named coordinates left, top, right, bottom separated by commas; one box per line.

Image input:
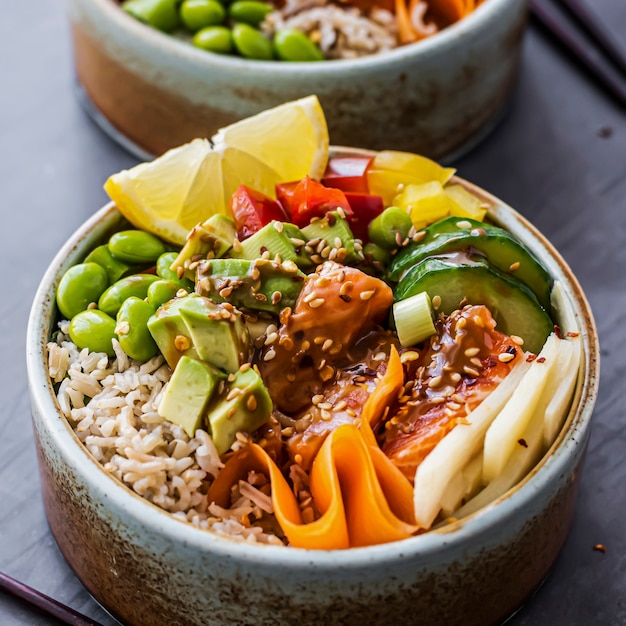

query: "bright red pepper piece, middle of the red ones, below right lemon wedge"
left=276, top=176, right=352, bottom=228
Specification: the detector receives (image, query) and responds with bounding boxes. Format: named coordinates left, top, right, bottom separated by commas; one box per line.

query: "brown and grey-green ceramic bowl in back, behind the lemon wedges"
left=66, top=0, right=527, bottom=159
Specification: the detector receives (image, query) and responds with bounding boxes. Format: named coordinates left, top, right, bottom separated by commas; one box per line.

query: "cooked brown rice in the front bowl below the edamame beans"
left=48, top=321, right=282, bottom=544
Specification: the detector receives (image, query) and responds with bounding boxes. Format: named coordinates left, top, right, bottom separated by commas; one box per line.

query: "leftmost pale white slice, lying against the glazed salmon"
left=413, top=361, right=530, bottom=528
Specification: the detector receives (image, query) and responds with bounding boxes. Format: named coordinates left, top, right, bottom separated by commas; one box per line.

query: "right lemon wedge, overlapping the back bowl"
left=212, top=96, right=329, bottom=182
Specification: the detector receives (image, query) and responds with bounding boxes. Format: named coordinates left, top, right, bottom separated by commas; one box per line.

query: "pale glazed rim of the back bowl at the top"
left=75, top=0, right=527, bottom=75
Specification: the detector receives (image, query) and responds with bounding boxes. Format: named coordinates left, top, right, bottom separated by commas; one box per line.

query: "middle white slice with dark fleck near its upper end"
left=483, top=334, right=561, bottom=484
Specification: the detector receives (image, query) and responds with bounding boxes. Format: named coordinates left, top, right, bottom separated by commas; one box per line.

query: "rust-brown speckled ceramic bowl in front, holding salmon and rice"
left=27, top=152, right=599, bottom=626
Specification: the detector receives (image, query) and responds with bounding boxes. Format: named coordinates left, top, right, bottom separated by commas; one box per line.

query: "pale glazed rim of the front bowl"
left=26, top=147, right=599, bottom=569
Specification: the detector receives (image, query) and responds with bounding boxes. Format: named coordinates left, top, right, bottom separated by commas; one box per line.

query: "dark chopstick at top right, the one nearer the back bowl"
left=529, top=0, right=626, bottom=105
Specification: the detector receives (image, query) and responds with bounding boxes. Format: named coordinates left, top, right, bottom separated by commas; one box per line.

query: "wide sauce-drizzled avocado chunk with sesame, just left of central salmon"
left=196, top=259, right=305, bottom=314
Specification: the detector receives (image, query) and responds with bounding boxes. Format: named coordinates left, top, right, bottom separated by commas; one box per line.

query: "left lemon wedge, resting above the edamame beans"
left=104, top=139, right=226, bottom=244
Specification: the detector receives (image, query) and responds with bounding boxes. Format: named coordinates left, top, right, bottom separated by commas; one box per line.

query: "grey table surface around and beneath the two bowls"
left=0, top=0, right=626, bottom=626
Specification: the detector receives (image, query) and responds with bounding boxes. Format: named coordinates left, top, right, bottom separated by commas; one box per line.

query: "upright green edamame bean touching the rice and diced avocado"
left=115, top=296, right=159, bottom=361
